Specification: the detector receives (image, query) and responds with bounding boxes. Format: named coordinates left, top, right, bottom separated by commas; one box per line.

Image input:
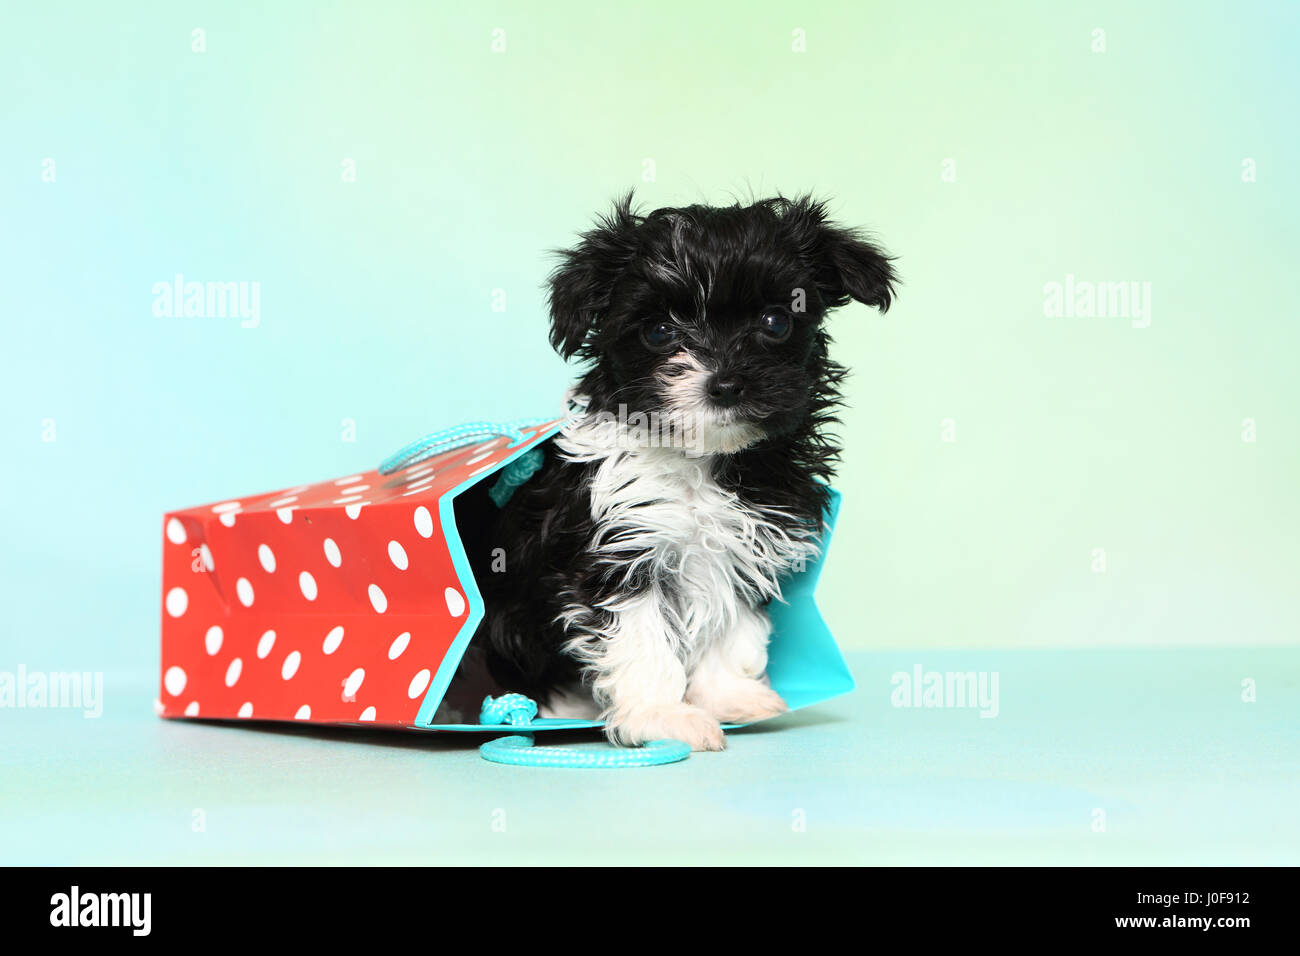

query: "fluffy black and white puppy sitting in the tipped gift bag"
left=476, top=194, right=894, bottom=750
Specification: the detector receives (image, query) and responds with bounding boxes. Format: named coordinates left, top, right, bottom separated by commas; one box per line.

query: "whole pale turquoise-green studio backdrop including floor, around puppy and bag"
left=0, top=1, right=1300, bottom=862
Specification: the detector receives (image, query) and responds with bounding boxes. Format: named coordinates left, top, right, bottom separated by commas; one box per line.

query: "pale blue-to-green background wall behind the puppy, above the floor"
left=0, top=3, right=1300, bottom=861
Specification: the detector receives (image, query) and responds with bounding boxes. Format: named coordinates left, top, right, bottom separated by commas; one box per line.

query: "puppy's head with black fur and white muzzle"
left=550, top=194, right=894, bottom=453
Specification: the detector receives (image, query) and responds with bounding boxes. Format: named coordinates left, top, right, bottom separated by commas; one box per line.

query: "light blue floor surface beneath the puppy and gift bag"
left=0, top=649, right=1300, bottom=865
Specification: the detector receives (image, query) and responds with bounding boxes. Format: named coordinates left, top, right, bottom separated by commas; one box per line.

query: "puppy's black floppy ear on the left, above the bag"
left=550, top=191, right=641, bottom=359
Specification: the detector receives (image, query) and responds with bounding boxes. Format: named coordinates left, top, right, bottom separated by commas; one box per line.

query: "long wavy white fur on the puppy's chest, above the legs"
left=556, top=419, right=818, bottom=657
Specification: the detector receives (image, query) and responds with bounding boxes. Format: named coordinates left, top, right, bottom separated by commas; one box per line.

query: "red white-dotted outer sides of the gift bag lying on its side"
left=155, top=418, right=564, bottom=727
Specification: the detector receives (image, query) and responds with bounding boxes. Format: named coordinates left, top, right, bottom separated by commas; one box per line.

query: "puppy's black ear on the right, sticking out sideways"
left=783, top=196, right=898, bottom=312
